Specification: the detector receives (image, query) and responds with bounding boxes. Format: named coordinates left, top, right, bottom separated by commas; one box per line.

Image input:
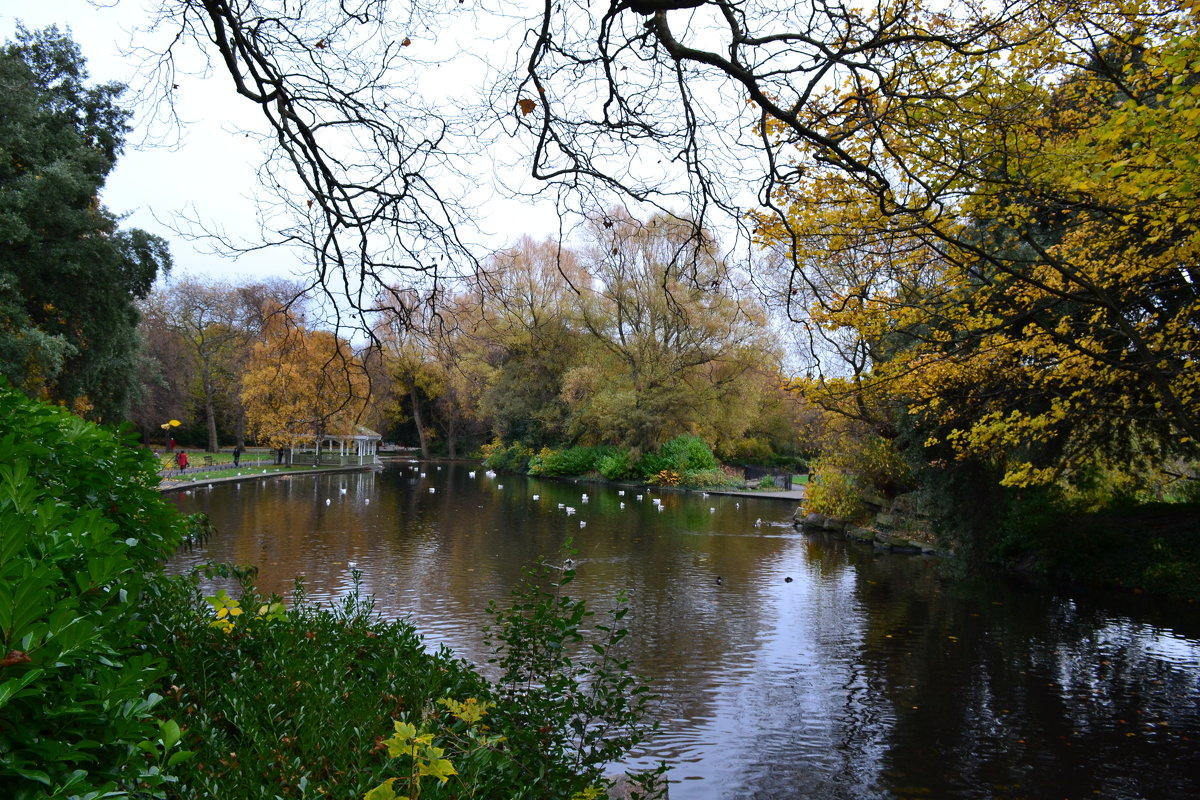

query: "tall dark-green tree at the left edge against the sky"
left=0, top=28, right=170, bottom=421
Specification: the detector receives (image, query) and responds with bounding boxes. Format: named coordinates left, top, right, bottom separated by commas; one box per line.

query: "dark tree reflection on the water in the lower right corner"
left=860, top=563, right=1200, bottom=798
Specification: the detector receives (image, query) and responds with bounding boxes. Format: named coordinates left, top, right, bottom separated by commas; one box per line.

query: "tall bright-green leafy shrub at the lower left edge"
left=0, top=387, right=186, bottom=800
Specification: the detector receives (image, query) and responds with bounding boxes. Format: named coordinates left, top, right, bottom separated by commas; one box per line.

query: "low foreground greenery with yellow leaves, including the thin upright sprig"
left=148, top=565, right=652, bottom=800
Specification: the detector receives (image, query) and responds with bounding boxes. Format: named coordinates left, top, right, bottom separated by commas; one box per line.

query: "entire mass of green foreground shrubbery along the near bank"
left=0, top=389, right=650, bottom=800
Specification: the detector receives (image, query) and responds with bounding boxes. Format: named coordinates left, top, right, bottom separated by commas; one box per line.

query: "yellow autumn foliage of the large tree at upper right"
left=756, top=0, right=1200, bottom=486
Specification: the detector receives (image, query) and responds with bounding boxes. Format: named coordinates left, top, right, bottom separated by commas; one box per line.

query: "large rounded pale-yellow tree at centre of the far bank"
left=563, top=211, right=779, bottom=450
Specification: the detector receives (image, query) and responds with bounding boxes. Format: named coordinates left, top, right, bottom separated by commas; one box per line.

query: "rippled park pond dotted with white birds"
left=172, top=463, right=1200, bottom=800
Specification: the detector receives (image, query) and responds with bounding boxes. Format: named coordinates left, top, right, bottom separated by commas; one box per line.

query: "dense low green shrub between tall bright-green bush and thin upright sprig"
left=146, top=566, right=489, bottom=800
